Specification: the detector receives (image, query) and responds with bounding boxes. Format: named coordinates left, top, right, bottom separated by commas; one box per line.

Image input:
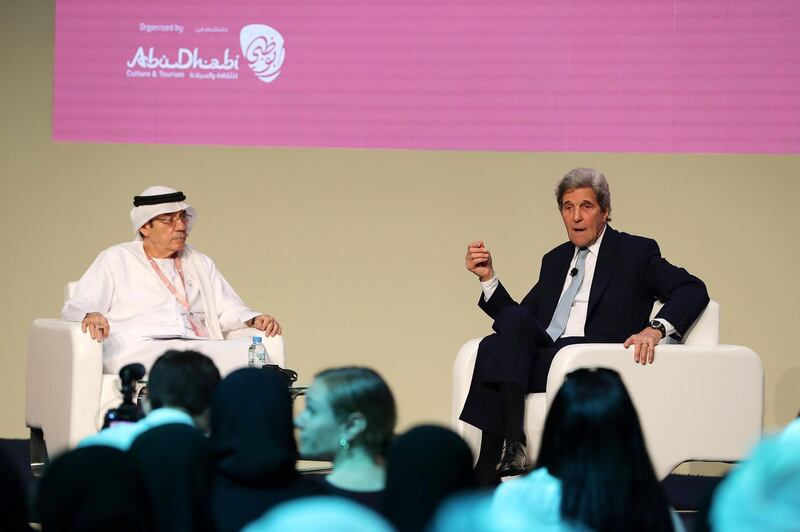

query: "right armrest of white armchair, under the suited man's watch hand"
left=546, top=344, right=764, bottom=478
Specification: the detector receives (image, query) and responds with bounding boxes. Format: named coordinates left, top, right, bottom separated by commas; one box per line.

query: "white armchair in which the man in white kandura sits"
left=25, top=283, right=286, bottom=463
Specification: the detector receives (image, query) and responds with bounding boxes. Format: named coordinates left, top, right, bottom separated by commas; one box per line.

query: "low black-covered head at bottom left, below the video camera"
left=38, top=445, right=154, bottom=532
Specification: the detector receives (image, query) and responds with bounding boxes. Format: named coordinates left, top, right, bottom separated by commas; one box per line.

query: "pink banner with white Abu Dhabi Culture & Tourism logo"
left=53, top=0, right=800, bottom=153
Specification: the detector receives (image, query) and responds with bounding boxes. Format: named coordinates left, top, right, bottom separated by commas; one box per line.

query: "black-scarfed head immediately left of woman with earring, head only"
left=211, top=368, right=297, bottom=488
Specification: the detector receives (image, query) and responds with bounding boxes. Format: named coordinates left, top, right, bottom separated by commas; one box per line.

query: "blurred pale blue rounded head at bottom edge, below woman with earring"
left=243, top=497, right=392, bottom=532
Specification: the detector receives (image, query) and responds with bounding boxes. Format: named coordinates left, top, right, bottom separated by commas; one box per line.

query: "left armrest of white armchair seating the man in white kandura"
left=25, top=319, right=103, bottom=457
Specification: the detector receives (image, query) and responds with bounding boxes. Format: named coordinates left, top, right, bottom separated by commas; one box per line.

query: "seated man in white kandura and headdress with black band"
left=61, top=186, right=281, bottom=375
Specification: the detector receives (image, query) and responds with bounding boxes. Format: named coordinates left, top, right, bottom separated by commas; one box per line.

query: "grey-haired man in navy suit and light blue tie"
left=461, top=168, right=708, bottom=483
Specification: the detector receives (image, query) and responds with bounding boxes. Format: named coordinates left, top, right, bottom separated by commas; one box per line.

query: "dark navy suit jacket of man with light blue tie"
left=478, top=226, right=708, bottom=343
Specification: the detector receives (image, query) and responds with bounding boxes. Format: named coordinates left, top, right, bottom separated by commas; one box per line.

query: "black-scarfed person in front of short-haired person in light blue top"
left=128, top=423, right=214, bottom=532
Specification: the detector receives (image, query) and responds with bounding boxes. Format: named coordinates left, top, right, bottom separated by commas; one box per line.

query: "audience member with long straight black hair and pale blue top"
left=492, top=368, right=685, bottom=532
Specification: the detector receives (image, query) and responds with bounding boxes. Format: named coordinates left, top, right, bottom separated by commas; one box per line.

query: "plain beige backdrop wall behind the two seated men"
left=0, top=0, right=800, bottom=446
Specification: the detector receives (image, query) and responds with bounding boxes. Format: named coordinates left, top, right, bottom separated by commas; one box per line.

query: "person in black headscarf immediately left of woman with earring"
left=211, top=368, right=315, bottom=532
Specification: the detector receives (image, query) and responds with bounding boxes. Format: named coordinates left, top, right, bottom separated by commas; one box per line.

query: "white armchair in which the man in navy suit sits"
left=452, top=301, right=764, bottom=478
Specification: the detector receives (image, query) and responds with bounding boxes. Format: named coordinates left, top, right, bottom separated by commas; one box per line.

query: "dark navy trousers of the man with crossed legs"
left=460, top=305, right=586, bottom=438
